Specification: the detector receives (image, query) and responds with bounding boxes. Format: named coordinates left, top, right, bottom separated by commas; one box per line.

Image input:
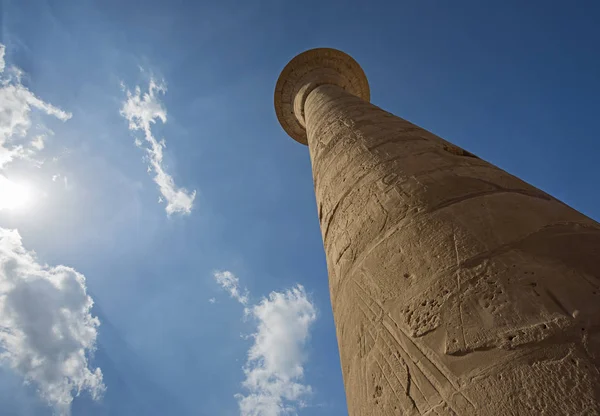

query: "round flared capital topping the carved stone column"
left=275, top=48, right=370, bottom=144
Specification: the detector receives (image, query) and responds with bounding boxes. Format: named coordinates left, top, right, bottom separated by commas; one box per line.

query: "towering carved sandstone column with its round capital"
left=275, top=49, right=600, bottom=416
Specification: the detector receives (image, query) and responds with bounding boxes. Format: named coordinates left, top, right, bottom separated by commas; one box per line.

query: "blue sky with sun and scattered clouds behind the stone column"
left=0, top=0, right=600, bottom=416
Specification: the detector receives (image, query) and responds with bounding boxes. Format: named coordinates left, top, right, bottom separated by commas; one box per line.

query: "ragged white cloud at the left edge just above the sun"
left=0, top=44, right=72, bottom=169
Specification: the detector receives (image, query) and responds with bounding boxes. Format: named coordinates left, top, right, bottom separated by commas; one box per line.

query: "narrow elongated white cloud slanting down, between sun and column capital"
left=121, top=79, right=196, bottom=214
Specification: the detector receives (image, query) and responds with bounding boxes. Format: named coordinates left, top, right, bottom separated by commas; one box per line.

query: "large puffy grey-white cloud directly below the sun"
left=0, top=228, right=105, bottom=415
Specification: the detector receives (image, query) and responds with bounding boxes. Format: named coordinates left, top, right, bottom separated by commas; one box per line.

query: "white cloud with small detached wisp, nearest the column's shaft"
left=215, top=272, right=317, bottom=416
